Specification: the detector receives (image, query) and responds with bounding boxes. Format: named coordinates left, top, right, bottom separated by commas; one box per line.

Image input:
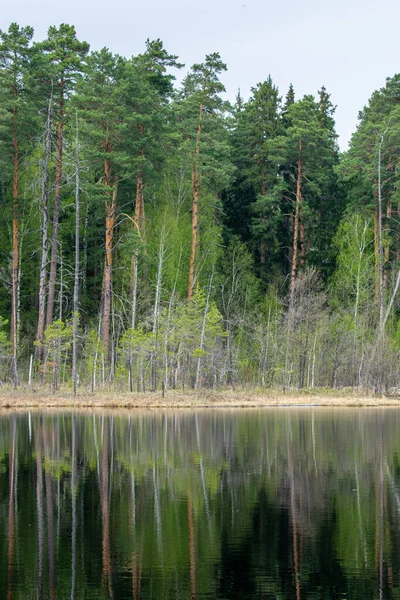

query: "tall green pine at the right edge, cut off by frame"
left=339, top=75, right=400, bottom=325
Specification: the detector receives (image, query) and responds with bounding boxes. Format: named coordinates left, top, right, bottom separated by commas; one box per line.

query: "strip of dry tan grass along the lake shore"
left=0, top=390, right=400, bottom=409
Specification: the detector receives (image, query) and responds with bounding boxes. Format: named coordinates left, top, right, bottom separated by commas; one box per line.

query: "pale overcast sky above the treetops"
left=0, top=0, right=400, bottom=150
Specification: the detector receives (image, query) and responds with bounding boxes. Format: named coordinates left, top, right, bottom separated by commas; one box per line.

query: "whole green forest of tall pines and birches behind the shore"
left=0, top=23, right=400, bottom=393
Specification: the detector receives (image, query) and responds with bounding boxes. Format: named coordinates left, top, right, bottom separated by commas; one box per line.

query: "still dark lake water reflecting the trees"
left=0, top=408, right=400, bottom=600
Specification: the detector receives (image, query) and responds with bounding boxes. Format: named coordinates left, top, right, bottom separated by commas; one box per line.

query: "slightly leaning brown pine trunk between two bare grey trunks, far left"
left=46, top=79, right=65, bottom=326
